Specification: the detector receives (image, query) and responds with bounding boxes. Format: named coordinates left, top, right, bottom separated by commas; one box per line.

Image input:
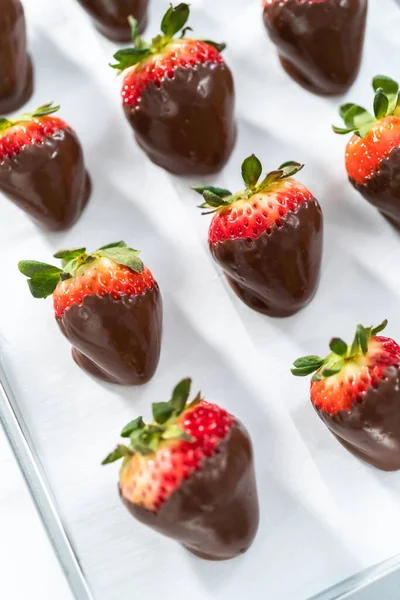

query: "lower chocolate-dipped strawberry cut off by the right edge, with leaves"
left=292, top=321, right=400, bottom=471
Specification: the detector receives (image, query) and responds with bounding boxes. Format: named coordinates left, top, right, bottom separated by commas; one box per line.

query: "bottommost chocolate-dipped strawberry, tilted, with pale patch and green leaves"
left=103, top=379, right=259, bottom=560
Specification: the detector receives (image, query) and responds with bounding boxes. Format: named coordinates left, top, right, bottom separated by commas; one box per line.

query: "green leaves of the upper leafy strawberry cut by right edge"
left=332, top=75, right=400, bottom=138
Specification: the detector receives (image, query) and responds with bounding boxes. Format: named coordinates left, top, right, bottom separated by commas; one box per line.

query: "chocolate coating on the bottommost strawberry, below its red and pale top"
left=122, top=422, right=259, bottom=560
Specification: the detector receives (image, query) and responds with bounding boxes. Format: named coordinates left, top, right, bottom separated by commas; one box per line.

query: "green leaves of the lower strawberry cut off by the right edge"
left=291, top=319, right=388, bottom=381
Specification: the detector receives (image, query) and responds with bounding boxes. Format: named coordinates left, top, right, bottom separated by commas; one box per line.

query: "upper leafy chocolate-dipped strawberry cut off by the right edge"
left=333, top=75, right=400, bottom=227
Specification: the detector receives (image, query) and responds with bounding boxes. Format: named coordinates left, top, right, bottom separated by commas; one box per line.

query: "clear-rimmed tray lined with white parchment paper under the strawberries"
left=0, top=0, right=400, bottom=600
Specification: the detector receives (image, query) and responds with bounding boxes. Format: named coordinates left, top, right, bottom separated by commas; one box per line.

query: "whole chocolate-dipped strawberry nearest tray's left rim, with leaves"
left=18, top=242, right=162, bottom=385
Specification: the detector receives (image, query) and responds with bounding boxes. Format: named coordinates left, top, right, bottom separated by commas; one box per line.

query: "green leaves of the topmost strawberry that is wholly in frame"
left=110, top=2, right=226, bottom=73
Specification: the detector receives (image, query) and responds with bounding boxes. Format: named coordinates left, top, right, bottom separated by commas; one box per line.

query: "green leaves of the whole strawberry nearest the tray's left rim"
left=18, top=241, right=144, bottom=298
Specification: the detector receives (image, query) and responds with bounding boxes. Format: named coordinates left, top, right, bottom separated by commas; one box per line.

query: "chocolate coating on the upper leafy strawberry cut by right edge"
left=349, top=148, right=400, bottom=228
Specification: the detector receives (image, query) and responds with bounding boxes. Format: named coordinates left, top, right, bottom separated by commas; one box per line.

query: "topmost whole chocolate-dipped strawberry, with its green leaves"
left=111, top=4, right=236, bottom=175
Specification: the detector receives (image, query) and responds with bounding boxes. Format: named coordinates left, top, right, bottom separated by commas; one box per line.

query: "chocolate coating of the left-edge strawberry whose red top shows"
left=0, top=128, right=91, bottom=231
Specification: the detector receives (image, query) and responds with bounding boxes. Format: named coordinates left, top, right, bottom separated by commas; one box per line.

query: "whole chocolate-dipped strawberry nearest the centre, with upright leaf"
left=193, top=154, right=323, bottom=317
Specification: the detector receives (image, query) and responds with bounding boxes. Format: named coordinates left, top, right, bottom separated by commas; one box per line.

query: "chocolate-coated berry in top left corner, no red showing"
left=0, top=0, right=33, bottom=115
